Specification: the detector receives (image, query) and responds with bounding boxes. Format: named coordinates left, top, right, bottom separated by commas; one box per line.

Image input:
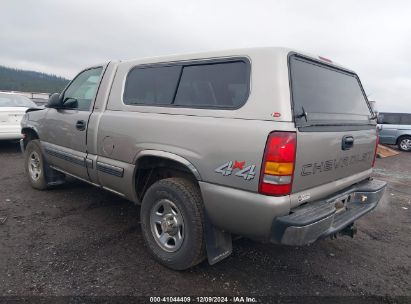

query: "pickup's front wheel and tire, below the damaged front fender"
left=24, top=139, right=47, bottom=190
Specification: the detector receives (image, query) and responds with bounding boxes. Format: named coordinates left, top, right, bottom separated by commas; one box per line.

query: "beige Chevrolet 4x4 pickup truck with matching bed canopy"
left=21, top=48, right=385, bottom=270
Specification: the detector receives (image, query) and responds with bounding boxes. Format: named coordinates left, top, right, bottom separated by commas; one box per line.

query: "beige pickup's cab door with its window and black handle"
left=42, top=66, right=104, bottom=180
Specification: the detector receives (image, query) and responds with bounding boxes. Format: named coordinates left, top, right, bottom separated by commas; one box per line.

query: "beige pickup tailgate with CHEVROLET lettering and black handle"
left=293, top=128, right=377, bottom=192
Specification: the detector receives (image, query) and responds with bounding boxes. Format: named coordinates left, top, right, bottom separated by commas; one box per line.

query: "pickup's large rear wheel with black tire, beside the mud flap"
left=140, top=178, right=205, bottom=270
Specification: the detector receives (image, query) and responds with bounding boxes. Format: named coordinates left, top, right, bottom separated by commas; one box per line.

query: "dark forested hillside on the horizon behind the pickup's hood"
left=0, top=66, right=68, bottom=93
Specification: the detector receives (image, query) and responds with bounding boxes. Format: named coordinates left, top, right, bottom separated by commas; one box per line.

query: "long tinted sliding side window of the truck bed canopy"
left=123, top=60, right=250, bottom=109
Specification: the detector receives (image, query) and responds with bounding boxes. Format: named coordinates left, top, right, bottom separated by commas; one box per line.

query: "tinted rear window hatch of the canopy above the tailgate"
left=290, top=55, right=372, bottom=125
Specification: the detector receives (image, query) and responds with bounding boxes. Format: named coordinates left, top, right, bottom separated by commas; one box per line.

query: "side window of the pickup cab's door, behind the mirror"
left=63, top=67, right=103, bottom=111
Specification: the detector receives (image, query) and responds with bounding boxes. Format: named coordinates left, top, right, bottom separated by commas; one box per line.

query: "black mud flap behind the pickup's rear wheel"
left=205, top=214, right=233, bottom=265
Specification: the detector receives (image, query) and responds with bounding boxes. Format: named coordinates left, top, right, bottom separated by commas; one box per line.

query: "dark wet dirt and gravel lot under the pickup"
left=0, top=142, right=411, bottom=296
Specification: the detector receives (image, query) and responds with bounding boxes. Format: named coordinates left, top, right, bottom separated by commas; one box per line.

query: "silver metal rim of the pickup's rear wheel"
left=150, top=199, right=184, bottom=252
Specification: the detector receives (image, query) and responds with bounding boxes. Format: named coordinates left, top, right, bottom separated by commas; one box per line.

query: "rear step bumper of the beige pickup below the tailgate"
left=271, top=180, right=387, bottom=246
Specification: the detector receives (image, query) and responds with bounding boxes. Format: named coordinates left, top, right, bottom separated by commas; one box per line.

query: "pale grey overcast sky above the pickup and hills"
left=0, top=0, right=411, bottom=113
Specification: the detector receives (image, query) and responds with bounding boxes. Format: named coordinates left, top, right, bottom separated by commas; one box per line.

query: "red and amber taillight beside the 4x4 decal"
left=259, top=132, right=297, bottom=196
